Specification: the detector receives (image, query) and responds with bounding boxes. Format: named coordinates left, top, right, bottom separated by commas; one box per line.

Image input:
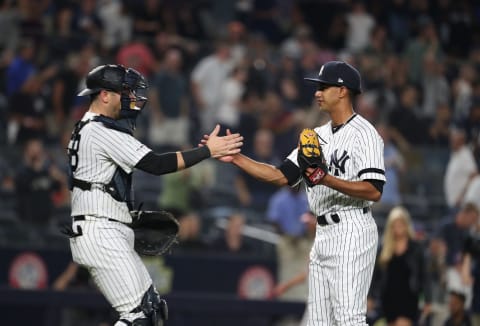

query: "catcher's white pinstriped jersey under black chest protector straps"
left=68, top=112, right=151, bottom=222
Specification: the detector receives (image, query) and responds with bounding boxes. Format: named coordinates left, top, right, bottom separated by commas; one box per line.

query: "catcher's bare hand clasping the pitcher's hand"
left=204, top=125, right=243, bottom=162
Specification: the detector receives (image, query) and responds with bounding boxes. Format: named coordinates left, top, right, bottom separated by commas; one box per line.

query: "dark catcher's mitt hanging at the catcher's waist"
left=130, top=210, right=179, bottom=256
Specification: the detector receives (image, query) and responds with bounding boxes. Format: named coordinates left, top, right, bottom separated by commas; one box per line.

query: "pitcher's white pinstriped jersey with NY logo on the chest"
left=287, top=114, right=386, bottom=216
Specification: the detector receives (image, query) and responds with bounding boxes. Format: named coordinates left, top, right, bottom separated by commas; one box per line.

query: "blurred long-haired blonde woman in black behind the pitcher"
left=374, top=206, right=431, bottom=326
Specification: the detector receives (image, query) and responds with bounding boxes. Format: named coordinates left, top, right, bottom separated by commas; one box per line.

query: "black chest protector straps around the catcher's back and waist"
left=68, top=115, right=133, bottom=210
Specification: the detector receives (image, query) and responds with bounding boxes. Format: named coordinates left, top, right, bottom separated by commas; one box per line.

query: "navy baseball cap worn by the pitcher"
left=305, top=61, right=362, bottom=94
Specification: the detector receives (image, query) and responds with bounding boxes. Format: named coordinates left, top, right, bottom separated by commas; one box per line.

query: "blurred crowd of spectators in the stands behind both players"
left=0, top=0, right=480, bottom=325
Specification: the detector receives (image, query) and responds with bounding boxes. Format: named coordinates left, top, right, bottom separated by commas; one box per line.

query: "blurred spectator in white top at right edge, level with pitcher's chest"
left=443, top=127, right=478, bottom=209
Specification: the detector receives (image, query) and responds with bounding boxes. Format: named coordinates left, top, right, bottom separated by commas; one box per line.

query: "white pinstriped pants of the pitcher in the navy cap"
left=307, top=210, right=378, bottom=326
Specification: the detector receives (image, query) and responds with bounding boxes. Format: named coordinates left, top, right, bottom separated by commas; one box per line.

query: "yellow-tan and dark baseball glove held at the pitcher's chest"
left=297, top=128, right=328, bottom=187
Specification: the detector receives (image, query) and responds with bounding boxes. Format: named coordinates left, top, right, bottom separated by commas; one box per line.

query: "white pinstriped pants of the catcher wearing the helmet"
left=70, top=218, right=152, bottom=320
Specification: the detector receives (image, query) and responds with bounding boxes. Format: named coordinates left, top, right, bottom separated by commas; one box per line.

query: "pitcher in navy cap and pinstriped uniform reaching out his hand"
left=210, top=61, right=386, bottom=326
